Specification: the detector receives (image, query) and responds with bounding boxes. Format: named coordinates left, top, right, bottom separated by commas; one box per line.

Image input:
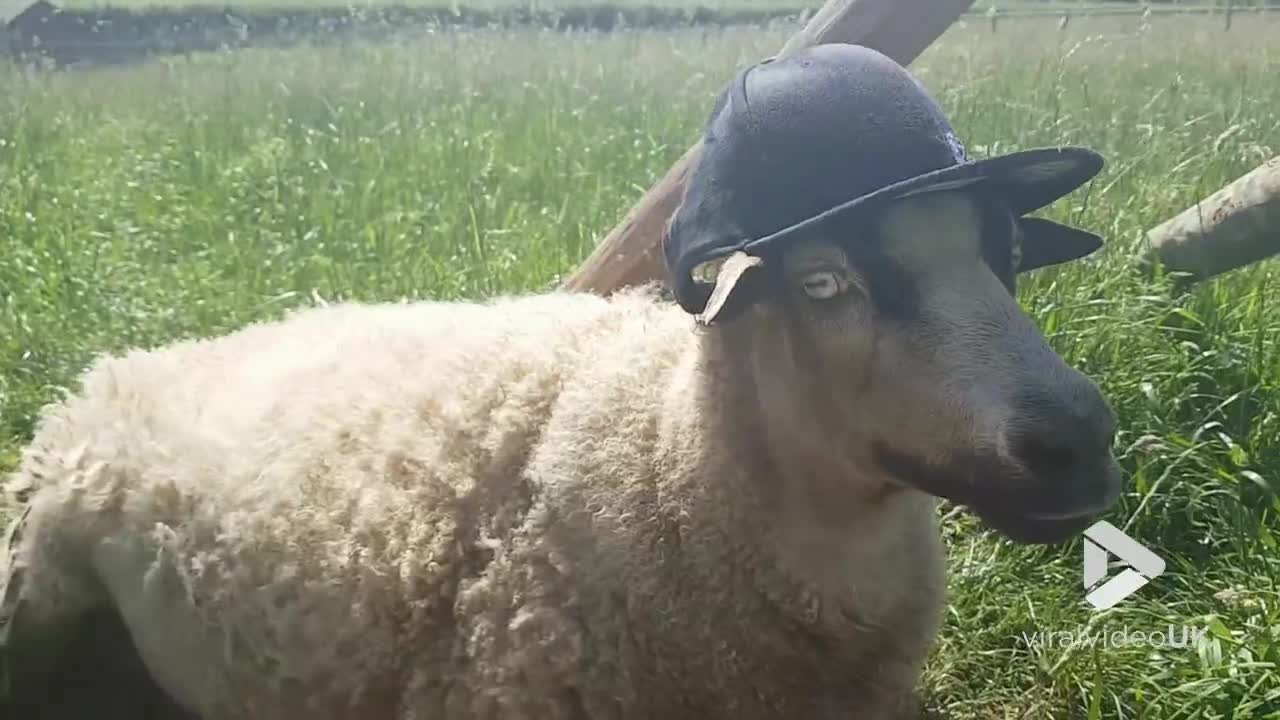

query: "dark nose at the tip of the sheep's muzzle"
left=1004, top=375, right=1120, bottom=515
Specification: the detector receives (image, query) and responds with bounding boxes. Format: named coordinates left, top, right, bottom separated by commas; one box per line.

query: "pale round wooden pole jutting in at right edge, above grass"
left=1143, top=156, right=1280, bottom=282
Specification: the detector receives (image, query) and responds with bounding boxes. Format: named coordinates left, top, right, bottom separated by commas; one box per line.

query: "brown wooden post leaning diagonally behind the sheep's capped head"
left=563, top=0, right=973, bottom=295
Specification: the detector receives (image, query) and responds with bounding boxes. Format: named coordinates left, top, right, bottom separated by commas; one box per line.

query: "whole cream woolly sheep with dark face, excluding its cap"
left=0, top=185, right=1116, bottom=720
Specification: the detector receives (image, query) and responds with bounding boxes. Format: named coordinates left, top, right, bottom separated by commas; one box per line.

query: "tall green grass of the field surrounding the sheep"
left=0, top=11, right=1280, bottom=720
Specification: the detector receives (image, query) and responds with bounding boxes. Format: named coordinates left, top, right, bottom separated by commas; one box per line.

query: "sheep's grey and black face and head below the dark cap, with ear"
left=701, top=192, right=1120, bottom=542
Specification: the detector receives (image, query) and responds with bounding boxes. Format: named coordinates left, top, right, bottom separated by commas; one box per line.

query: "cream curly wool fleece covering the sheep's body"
left=0, top=285, right=942, bottom=720
